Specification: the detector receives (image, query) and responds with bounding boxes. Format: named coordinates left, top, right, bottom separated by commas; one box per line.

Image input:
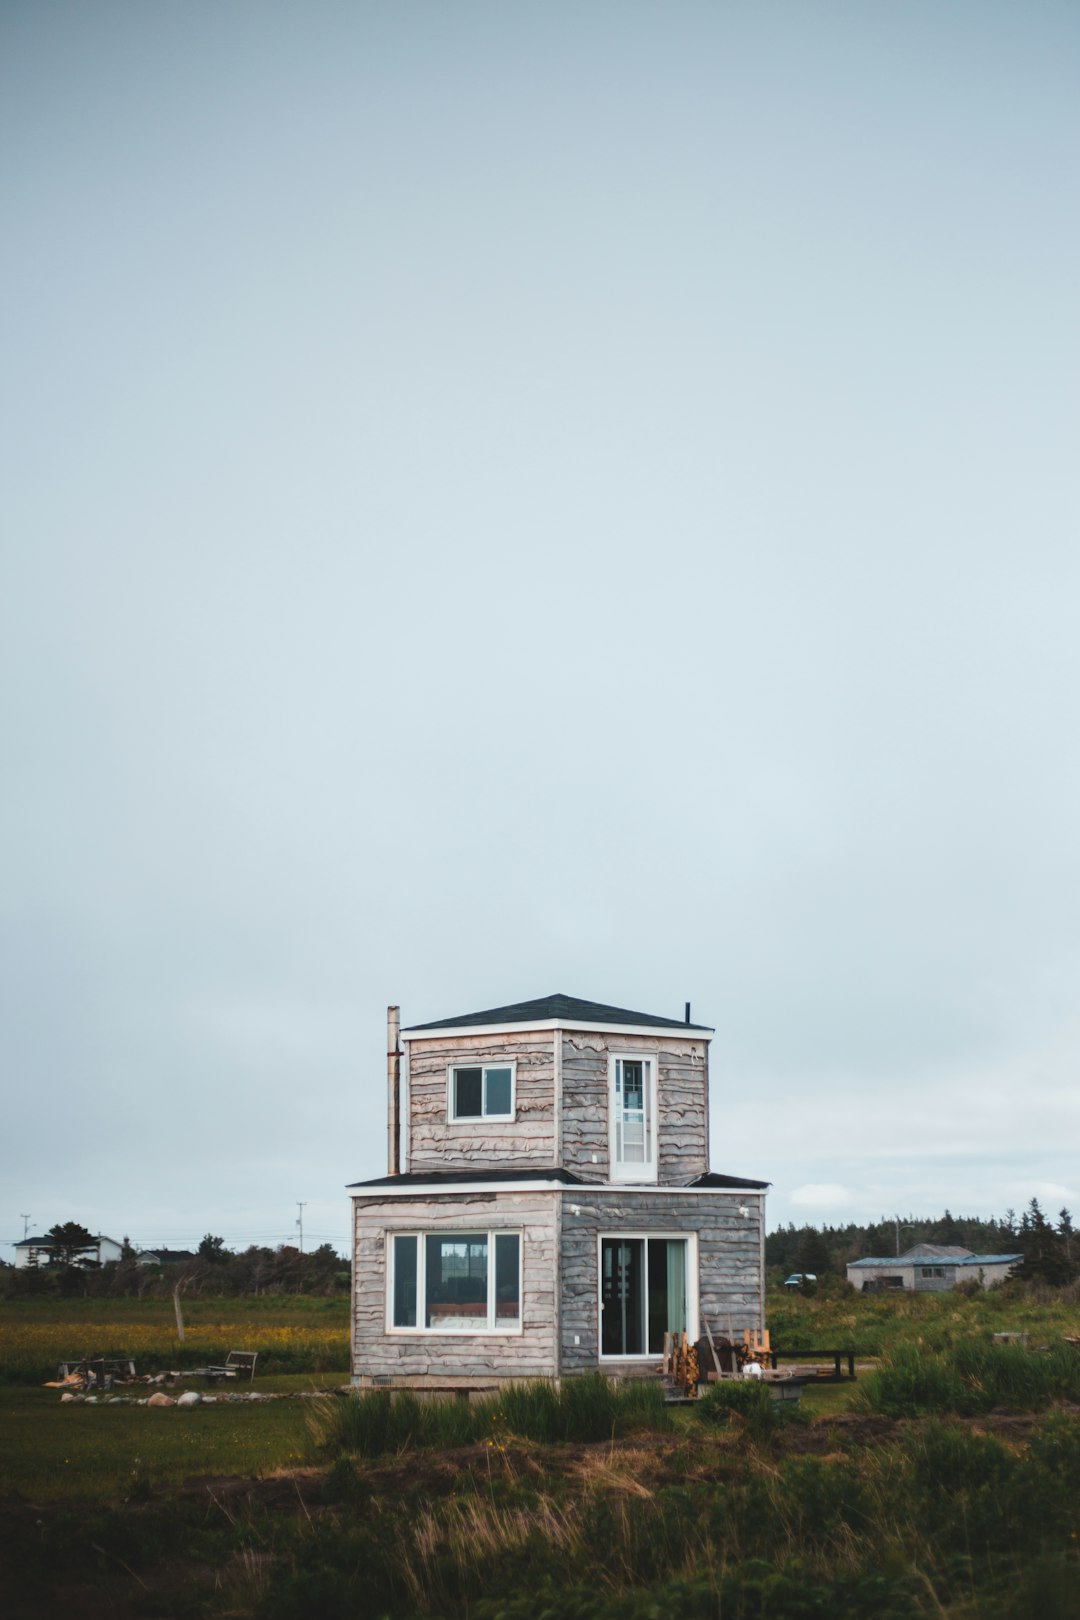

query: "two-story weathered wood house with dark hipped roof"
left=350, top=995, right=767, bottom=1388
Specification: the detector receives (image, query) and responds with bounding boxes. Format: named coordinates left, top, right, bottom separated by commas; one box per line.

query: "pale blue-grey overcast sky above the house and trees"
left=0, top=0, right=1080, bottom=1259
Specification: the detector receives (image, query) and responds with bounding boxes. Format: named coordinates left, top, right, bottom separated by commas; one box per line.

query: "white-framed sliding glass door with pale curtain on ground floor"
left=597, top=1233, right=698, bottom=1361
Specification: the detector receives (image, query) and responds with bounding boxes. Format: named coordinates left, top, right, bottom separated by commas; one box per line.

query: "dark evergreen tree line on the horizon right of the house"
left=764, top=1199, right=1080, bottom=1286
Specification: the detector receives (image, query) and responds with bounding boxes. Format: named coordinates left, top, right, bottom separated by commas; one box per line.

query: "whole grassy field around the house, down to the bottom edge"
left=0, top=1291, right=1080, bottom=1620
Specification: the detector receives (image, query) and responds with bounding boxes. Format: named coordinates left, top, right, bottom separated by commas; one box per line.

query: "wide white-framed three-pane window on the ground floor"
left=387, top=1231, right=521, bottom=1333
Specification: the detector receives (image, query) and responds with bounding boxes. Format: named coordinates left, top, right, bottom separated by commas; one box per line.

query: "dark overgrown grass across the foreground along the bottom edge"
left=12, top=1403, right=1080, bottom=1620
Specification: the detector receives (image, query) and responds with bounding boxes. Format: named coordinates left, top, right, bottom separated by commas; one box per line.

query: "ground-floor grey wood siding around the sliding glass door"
left=559, top=1187, right=764, bottom=1374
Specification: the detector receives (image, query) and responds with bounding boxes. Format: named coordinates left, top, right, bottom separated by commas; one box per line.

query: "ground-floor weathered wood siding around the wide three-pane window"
left=353, top=1191, right=559, bottom=1385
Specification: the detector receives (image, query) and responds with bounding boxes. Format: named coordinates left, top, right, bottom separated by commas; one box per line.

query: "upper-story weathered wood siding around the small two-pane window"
left=406, top=1030, right=555, bottom=1171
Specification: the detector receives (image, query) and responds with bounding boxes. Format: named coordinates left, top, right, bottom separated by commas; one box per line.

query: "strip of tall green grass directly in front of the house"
left=311, top=1372, right=670, bottom=1456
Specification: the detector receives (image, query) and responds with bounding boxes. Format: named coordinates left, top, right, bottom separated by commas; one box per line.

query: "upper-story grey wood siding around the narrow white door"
left=562, top=1030, right=709, bottom=1186
